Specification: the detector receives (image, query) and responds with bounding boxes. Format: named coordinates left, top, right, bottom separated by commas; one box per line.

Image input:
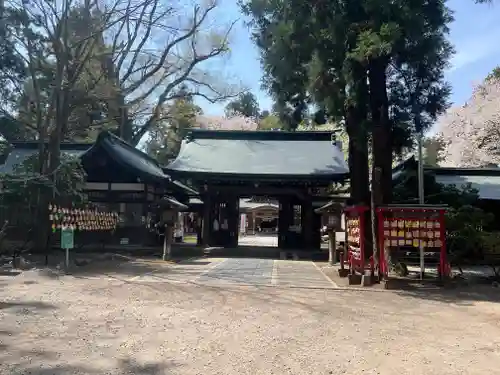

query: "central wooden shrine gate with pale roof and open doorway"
left=164, top=130, right=348, bottom=253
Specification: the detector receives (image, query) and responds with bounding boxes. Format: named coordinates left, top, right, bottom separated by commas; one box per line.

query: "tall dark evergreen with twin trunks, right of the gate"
left=243, top=0, right=451, bottom=268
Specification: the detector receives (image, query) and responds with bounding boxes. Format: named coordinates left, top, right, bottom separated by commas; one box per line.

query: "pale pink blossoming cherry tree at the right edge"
left=436, top=72, right=500, bottom=167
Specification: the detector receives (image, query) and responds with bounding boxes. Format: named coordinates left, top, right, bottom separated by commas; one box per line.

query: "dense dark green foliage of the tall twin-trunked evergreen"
left=242, top=0, right=452, bottom=153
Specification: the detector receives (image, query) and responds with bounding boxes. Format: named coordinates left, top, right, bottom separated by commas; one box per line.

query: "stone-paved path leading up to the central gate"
left=129, top=258, right=336, bottom=289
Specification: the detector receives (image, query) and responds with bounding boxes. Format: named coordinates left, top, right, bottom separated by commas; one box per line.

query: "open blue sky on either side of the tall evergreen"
left=200, top=0, right=500, bottom=115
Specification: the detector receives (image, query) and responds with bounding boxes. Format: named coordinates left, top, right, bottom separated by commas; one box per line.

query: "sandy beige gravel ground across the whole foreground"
left=0, top=271, right=500, bottom=375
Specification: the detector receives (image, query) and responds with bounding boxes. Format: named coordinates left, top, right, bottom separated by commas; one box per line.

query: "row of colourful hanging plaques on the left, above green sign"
left=49, top=204, right=118, bottom=232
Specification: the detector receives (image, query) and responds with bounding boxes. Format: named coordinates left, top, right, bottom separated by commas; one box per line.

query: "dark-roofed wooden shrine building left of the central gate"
left=0, top=131, right=198, bottom=245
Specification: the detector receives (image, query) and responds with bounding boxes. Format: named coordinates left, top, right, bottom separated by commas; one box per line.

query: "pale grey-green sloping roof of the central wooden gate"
left=166, top=130, right=348, bottom=179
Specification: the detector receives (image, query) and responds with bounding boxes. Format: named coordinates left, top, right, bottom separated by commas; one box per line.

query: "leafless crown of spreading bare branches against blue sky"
left=103, top=0, right=239, bottom=144
